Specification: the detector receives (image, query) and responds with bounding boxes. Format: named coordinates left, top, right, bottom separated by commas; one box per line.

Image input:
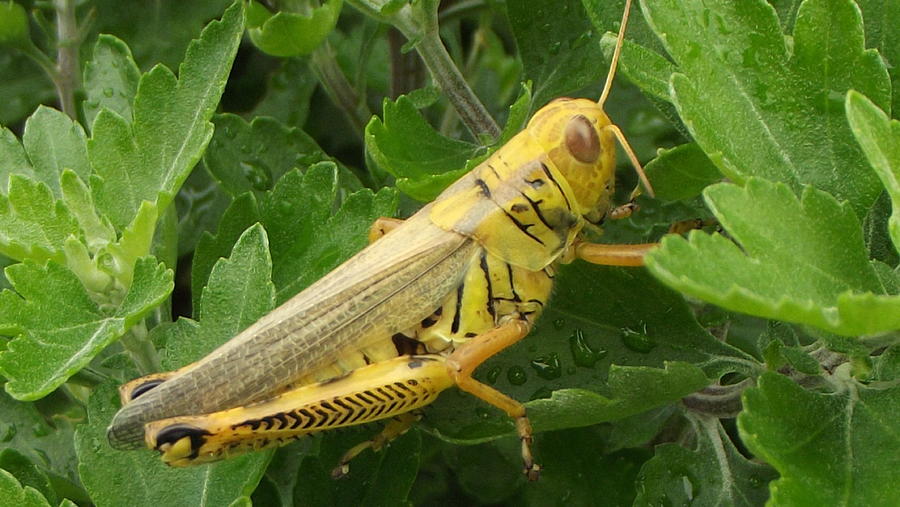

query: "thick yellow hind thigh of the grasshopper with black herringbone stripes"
left=145, top=355, right=453, bottom=466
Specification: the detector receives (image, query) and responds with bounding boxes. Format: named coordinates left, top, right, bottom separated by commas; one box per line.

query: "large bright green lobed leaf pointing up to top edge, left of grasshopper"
left=88, top=3, right=243, bottom=229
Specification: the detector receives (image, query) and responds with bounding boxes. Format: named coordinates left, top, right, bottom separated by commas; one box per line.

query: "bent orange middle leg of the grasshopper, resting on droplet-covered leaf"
left=447, top=316, right=541, bottom=481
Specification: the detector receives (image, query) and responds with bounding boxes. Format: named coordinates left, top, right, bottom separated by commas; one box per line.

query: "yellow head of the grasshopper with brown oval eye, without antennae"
left=527, top=98, right=616, bottom=222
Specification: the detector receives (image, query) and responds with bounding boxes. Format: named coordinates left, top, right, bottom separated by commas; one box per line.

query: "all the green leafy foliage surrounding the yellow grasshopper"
left=0, top=0, right=900, bottom=506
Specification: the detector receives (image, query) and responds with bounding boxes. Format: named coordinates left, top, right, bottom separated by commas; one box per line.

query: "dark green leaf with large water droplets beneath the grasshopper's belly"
left=426, top=263, right=760, bottom=443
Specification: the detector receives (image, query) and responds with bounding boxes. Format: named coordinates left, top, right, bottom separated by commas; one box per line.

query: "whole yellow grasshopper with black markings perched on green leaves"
left=108, top=0, right=653, bottom=479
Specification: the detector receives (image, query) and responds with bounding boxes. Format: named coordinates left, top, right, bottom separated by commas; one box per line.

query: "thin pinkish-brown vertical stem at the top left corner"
left=53, top=0, right=80, bottom=120
